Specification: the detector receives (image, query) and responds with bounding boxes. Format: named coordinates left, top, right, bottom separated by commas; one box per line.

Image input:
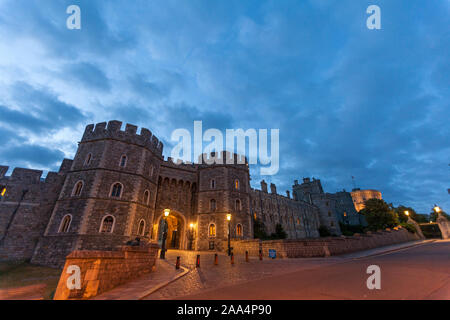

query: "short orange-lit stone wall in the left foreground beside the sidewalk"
left=54, top=244, right=159, bottom=300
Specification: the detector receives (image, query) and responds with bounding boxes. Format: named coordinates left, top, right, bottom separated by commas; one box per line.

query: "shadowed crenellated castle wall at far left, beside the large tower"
left=0, top=159, right=72, bottom=260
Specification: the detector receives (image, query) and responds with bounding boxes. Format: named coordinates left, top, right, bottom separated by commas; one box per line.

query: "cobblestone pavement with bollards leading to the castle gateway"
left=145, top=250, right=343, bottom=300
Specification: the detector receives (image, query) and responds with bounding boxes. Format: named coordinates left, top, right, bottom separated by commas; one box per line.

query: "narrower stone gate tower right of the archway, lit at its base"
left=198, top=151, right=253, bottom=250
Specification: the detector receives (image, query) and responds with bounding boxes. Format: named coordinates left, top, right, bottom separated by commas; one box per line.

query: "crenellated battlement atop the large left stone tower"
left=81, top=120, right=163, bottom=156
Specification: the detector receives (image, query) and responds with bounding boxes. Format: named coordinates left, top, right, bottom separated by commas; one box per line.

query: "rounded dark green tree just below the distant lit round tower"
left=360, top=199, right=399, bottom=231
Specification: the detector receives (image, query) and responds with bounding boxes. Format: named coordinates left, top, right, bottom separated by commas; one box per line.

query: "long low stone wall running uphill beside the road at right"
left=231, top=228, right=420, bottom=258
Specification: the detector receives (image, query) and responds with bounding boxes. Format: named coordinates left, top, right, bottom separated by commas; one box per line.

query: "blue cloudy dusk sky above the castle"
left=0, top=0, right=450, bottom=213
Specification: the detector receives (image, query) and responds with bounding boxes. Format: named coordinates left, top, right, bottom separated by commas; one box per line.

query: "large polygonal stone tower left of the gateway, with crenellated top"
left=32, top=121, right=163, bottom=266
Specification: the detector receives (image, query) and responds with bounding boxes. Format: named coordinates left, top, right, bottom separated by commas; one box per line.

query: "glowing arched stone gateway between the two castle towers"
left=155, top=210, right=187, bottom=249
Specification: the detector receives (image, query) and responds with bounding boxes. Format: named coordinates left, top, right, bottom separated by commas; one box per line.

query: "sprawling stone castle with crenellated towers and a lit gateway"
left=0, top=121, right=359, bottom=267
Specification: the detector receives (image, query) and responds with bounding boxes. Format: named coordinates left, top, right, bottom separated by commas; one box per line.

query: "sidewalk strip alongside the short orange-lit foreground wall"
left=91, top=259, right=189, bottom=300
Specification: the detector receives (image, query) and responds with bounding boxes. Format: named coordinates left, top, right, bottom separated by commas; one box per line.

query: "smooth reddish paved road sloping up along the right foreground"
left=177, top=240, right=450, bottom=300
